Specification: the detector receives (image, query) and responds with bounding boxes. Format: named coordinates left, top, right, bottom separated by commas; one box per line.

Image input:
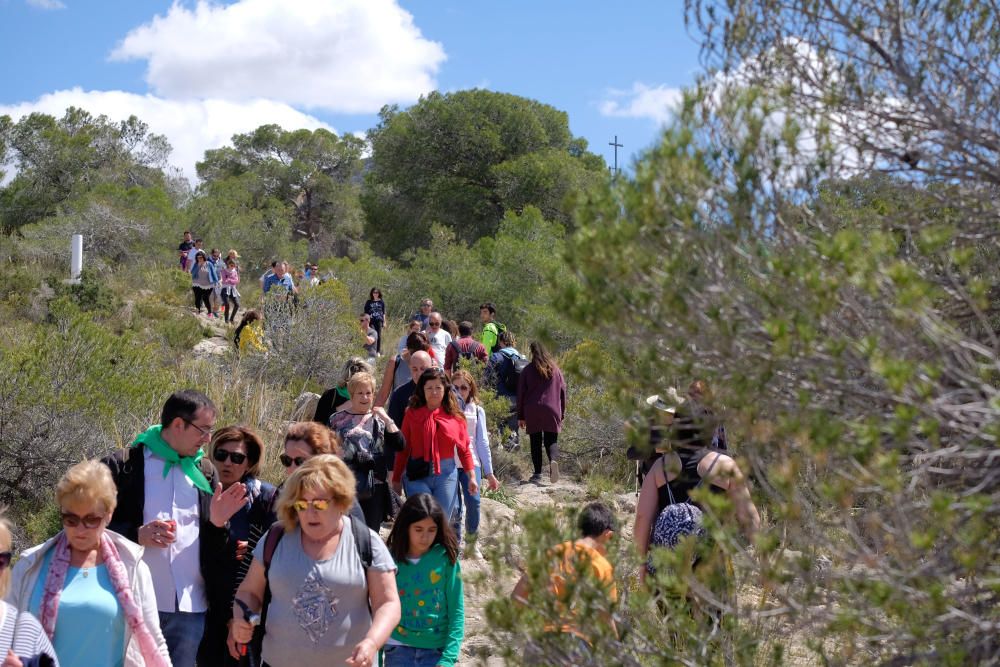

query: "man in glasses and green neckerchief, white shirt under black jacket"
left=102, top=389, right=246, bottom=667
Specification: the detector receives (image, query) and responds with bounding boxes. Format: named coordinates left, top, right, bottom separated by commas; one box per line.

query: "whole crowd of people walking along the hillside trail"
left=0, top=264, right=760, bottom=667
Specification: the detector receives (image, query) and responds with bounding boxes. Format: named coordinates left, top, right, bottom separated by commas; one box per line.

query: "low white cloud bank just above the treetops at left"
left=0, top=88, right=333, bottom=183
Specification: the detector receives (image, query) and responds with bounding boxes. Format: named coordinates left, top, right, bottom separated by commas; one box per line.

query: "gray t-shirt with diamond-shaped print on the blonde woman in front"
left=253, top=516, right=396, bottom=667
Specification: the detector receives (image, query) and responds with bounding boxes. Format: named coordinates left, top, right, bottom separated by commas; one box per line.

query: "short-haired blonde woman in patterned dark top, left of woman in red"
left=330, top=372, right=403, bottom=531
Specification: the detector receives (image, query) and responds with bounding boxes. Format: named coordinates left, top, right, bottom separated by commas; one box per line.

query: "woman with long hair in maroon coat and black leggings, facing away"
left=517, top=341, right=566, bottom=484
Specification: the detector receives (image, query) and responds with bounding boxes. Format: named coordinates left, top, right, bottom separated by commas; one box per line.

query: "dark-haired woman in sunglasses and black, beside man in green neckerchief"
left=198, top=426, right=277, bottom=665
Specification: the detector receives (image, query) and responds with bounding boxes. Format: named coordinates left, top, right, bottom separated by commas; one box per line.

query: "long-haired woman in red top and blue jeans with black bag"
left=392, top=368, right=479, bottom=517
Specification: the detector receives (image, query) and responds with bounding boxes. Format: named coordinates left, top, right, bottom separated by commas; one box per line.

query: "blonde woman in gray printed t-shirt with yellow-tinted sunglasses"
left=230, top=455, right=400, bottom=667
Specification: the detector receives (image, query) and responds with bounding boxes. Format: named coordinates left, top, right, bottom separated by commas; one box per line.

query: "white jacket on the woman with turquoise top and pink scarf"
left=7, top=530, right=170, bottom=667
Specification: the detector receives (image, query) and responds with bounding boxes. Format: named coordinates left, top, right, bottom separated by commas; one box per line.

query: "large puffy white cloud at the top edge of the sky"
left=111, top=0, right=445, bottom=113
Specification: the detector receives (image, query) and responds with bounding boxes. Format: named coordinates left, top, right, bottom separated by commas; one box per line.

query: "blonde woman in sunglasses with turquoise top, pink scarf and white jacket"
left=8, top=461, right=170, bottom=667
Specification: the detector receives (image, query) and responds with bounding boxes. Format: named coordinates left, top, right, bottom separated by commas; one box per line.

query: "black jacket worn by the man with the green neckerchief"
left=101, top=445, right=229, bottom=600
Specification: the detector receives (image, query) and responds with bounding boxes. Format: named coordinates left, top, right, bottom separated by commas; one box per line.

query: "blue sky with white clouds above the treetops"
left=0, top=0, right=699, bottom=181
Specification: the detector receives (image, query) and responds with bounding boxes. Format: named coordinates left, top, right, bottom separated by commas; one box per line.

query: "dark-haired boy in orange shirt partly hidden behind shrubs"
left=512, top=502, right=618, bottom=664
